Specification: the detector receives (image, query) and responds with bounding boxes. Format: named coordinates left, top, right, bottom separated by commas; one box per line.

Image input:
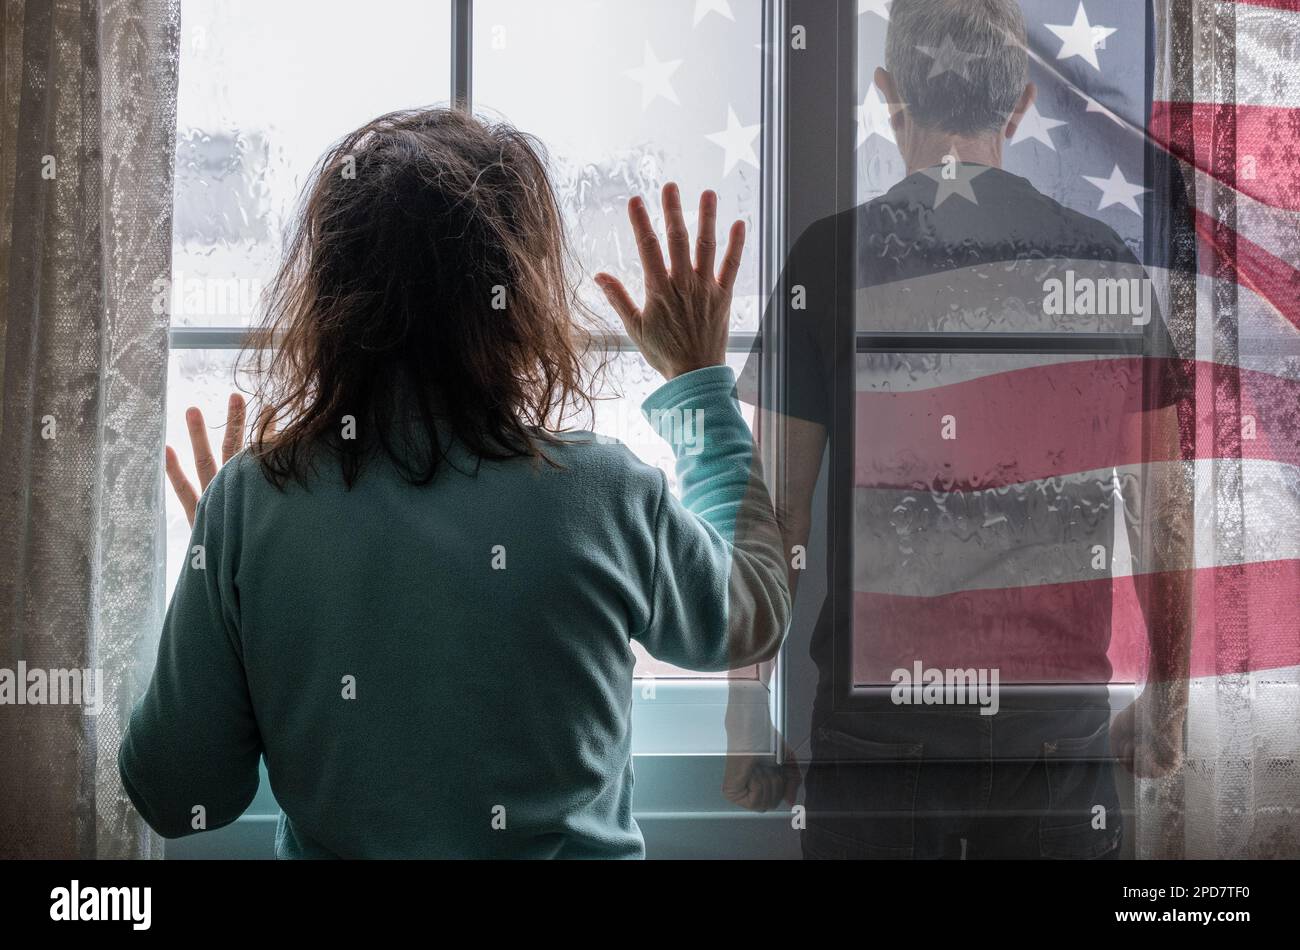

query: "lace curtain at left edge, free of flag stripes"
left=0, top=0, right=179, bottom=858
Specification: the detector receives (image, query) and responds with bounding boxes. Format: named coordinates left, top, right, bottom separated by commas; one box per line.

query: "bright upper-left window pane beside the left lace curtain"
left=172, top=0, right=451, bottom=326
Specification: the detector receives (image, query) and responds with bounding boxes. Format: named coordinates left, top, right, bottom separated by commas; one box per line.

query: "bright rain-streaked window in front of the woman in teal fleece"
left=168, top=0, right=767, bottom=751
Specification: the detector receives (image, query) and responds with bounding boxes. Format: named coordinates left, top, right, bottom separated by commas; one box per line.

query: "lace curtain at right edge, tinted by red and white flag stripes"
left=1138, top=0, right=1300, bottom=858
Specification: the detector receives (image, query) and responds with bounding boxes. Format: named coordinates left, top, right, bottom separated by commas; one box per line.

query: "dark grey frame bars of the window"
left=159, top=0, right=1141, bottom=752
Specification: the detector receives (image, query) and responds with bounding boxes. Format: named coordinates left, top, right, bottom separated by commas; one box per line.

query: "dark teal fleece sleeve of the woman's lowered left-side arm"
left=117, top=459, right=261, bottom=838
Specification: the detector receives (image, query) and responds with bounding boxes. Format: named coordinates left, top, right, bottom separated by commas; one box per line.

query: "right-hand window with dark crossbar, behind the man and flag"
left=836, top=0, right=1160, bottom=689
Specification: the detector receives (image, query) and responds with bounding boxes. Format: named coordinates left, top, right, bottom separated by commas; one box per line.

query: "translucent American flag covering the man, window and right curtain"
left=759, top=0, right=1300, bottom=856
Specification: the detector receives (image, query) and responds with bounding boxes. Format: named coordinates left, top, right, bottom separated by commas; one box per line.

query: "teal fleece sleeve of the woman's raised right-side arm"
left=633, top=366, right=790, bottom=671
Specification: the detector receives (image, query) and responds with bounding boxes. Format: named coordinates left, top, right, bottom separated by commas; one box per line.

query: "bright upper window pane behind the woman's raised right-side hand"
left=473, top=0, right=763, bottom=330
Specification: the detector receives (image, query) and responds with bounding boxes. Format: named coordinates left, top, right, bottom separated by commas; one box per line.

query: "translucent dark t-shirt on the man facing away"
left=740, top=164, right=1183, bottom=712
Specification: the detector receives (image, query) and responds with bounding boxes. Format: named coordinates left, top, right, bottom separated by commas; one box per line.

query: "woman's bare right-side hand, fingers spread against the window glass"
left=595, top=182, right=745, bottom=379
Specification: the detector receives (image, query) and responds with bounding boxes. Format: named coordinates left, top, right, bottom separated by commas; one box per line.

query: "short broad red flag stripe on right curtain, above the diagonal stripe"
left=1151, top=101, right=1300, bottom=211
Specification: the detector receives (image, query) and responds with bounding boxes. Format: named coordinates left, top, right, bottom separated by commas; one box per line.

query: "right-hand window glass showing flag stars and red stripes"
left=857, top=0, right=1167, bottom=685
